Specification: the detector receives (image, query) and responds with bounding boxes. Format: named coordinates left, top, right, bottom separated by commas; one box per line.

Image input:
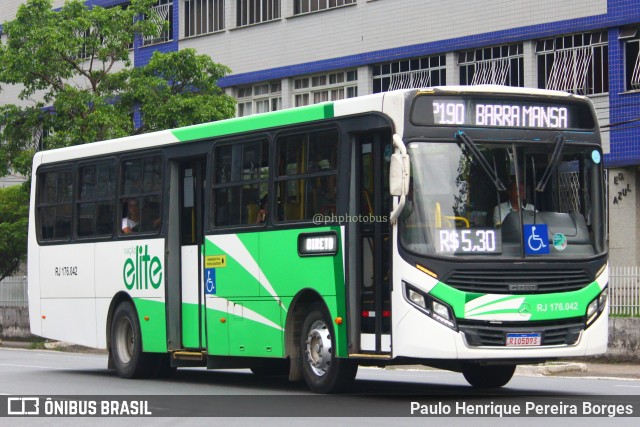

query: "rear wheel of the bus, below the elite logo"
left=110, top=301, right=158, bottom=378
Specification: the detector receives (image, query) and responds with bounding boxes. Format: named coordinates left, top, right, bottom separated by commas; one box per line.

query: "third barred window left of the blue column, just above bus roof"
left=373, top=55, right=447, bottom=93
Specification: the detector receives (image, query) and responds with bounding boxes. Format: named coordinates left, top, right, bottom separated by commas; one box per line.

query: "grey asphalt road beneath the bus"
left=0, top=348, right=640, bottom=427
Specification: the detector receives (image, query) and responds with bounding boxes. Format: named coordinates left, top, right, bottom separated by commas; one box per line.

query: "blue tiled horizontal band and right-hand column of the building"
left=214, top=0, right=640, bottom=166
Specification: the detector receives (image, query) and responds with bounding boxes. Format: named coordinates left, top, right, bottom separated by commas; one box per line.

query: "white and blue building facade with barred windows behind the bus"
left=0, top=0, right=640, bottom=266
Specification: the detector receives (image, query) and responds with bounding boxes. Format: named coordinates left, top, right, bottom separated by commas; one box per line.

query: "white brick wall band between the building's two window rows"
left=180, top=0, right=607, bottom=73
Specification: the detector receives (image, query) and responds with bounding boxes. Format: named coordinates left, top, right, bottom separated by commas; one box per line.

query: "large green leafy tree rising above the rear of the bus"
left=0, top=0, right=235, bottom=174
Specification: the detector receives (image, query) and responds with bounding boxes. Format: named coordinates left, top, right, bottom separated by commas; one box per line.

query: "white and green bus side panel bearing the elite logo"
left=95, top=239, right=167, bottom=352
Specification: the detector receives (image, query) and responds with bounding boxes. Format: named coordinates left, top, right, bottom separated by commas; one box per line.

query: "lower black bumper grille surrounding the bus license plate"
left=457, top=318, right=585, bottom=347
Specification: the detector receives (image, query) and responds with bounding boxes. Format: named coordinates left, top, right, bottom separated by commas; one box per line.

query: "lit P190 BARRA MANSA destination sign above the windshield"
left=411, top=96, right=595, bottom=129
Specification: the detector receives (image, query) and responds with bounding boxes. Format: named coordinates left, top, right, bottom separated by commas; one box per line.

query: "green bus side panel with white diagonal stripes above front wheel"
left=204, top=227, right=346, bottom=357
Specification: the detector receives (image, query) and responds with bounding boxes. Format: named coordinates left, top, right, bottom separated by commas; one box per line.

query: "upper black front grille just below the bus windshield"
left=442, top=270, right=593, bottom=295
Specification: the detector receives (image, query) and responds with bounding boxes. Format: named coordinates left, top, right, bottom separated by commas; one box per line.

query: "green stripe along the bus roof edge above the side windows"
left=171, top=103, right=334, bottom=142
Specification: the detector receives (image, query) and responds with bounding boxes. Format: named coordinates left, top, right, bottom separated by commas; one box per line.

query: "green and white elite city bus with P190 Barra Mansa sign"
left=28, top=86, right=608, bottom=392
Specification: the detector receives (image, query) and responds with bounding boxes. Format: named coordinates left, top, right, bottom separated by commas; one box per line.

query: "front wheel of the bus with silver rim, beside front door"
left=300, top=303, right=358, bottom=393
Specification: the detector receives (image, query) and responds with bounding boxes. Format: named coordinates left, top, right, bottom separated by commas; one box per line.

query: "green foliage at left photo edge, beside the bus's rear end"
left=0, top=185, right=29, bottom=280
